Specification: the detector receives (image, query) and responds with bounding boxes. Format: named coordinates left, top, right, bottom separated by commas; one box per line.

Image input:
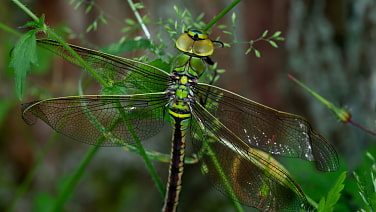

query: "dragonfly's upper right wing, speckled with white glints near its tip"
left=195, top=84, right=339, bottom=171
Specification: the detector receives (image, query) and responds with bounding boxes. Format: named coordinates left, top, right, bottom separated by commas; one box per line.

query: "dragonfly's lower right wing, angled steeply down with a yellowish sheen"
left=190, top=103, right=308, bottom=211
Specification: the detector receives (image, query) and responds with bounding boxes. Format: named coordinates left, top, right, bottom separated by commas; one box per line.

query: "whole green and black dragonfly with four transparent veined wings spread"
left=22, top=29, right=339, bottom=212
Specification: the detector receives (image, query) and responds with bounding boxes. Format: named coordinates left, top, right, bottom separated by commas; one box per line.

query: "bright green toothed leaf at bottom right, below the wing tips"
left=318, top=172, right=347, bottom=212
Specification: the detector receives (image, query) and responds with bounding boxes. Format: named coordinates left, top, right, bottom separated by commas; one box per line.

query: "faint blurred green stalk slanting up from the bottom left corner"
left=5, top=133, right=57, bottom=212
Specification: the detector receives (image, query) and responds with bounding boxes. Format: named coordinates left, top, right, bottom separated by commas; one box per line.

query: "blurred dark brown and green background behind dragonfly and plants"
left=0, top=0, right=376, bottom=211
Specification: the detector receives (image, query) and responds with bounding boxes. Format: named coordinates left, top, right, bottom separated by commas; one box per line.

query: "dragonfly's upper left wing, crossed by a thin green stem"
left=37, top=39, right=169, bottom=94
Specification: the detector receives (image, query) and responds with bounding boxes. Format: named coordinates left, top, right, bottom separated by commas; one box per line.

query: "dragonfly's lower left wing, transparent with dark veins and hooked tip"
left=22, top=93, right=167, bottom=146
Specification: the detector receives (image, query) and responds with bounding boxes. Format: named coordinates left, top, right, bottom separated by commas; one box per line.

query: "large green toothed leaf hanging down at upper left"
left=9, top=29, right=38, bottom=99
